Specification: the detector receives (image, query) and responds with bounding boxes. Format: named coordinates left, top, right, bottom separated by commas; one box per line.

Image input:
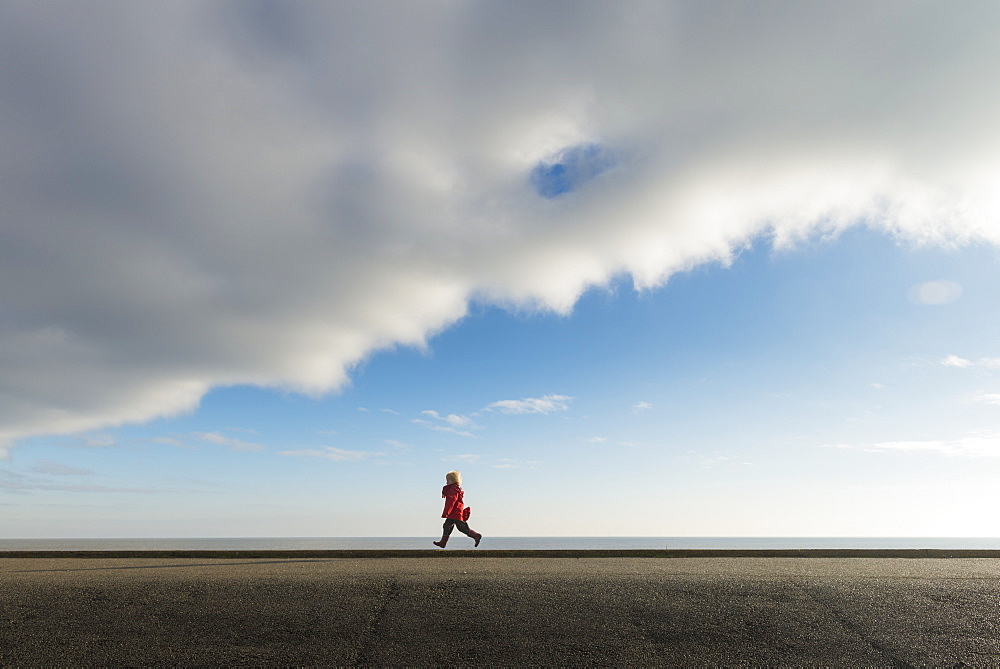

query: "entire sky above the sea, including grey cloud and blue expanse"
left=0, top=0, right=1000, bottom=538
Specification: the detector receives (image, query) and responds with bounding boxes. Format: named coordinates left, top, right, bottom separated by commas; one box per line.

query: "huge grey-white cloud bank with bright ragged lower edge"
left=0, top=0, right=1000, bottom=451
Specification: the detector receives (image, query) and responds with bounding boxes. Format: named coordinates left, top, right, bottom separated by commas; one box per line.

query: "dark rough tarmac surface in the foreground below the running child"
left=0, top=551, right=1000, bottom=667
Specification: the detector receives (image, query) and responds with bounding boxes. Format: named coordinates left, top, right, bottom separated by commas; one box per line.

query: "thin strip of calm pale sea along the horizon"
left=0, top=532, right=1000, bottom=551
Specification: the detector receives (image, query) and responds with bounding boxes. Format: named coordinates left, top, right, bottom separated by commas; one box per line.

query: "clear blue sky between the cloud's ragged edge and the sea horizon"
left=5, top=230, right=1000, bottom=536
